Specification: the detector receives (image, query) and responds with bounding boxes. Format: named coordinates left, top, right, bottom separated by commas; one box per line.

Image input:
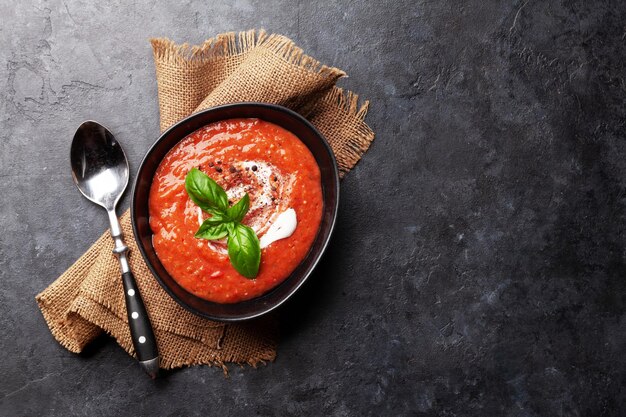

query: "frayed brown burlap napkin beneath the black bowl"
left=36, top=31, right=374, bottom=369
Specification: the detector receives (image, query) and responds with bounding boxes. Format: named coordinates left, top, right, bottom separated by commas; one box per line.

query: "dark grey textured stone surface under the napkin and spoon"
left=0, top=0, right=626, bottom=416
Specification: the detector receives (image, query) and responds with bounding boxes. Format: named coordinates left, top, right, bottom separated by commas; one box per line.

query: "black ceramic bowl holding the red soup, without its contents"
left=131, top=103, right=339, bottom=321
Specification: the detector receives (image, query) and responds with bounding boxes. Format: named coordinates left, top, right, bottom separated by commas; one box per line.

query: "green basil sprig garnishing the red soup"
left=185, top=168, right=261, bottom=279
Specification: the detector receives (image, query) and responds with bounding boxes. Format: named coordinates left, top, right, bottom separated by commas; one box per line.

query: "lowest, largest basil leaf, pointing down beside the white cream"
left=228, top=223, right=261, bottom=279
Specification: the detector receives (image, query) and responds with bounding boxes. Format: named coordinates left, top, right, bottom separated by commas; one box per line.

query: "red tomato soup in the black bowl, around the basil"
left=149, top=119, right=323, bottom=303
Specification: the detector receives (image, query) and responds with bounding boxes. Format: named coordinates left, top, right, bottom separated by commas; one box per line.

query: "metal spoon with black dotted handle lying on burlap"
left=70, top=121, right=159, bottom=378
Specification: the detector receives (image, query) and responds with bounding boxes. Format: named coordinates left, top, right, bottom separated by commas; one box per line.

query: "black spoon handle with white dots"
left=122, top=271, right=159, bottom=378
